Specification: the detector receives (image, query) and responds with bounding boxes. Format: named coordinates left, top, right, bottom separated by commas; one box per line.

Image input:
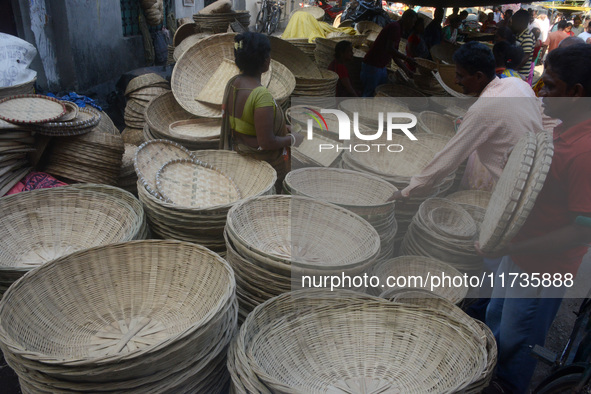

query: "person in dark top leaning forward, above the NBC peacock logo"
left=361, top=8, right=417, bottom=97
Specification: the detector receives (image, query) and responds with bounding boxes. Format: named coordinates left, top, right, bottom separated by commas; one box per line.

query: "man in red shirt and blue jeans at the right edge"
left=475, top=44, right=591, bottom=394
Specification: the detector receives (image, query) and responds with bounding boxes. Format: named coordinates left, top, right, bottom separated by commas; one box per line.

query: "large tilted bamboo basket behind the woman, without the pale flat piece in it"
left=171, top=33, right=301, bottom=118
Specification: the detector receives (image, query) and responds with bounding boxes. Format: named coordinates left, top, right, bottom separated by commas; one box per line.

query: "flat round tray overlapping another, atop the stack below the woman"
left=156, top=159, right=242, bottom=208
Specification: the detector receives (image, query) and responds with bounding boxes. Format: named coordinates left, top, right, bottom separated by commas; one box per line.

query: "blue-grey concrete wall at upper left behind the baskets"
left=13, top=0, right=145, bottom=91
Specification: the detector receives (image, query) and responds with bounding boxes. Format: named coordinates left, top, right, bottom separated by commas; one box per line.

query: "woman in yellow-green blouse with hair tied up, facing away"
left=220, top=32, right=303, bottom=193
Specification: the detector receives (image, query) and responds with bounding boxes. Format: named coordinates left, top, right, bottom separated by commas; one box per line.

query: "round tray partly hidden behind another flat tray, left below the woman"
left=133, top=140, right=195, bottom=198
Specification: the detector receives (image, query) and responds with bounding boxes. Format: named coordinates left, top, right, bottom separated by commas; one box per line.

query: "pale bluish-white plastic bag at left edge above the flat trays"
left=0, top=33, right=37, bottom=88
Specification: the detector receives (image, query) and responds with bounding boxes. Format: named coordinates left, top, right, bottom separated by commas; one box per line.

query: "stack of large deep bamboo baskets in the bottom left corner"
left=0, top=239, right=237, bottom=393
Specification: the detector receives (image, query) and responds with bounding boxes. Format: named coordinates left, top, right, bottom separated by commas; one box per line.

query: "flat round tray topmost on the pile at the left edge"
left=0, top=94, right=66, bottom=124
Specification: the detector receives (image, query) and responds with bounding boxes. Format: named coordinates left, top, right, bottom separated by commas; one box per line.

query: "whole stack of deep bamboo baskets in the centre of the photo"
left=224, top=195, right=380, bottom=320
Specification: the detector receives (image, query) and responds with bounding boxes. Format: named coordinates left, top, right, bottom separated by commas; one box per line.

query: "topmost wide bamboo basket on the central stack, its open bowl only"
left=226, top=196, right=380, bottom=271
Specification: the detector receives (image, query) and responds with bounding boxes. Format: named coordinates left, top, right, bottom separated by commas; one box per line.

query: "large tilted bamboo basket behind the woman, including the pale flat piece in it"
left=171, top=33, right=296, bottom=118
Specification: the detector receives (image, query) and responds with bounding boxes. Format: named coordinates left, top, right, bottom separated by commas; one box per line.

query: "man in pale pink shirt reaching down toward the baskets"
left=393, top=41, right=543, bottom=199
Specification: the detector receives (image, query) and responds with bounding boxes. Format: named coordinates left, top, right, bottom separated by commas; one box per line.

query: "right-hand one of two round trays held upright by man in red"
left=499, top=132, right=554, bottom=246
